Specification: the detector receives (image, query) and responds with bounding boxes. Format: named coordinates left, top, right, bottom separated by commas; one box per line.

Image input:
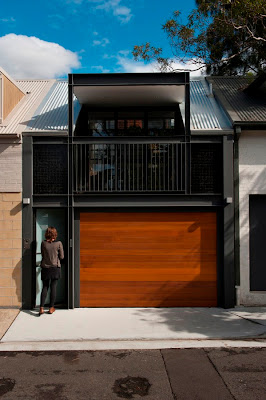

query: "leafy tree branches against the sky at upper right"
left=132, top=0, right=266, bottom=75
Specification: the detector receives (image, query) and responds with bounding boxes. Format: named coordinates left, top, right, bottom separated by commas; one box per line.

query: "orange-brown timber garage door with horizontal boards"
left=80, top=212, right=217, bottom=307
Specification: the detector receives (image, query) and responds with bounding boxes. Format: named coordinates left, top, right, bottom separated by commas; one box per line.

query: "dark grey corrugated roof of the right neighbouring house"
left=208, top=76, right=266, bottom=122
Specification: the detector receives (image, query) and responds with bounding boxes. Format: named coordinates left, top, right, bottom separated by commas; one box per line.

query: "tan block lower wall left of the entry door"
left=0, top=193, right=22, bottom=307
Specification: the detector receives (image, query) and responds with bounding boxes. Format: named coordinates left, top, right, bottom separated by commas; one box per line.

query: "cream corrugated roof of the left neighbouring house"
left=0, top=80, right=55, bottom=135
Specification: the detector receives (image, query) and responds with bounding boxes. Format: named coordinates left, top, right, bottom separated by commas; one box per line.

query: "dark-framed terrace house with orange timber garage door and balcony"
left=22, top=73, right=235, bottom=308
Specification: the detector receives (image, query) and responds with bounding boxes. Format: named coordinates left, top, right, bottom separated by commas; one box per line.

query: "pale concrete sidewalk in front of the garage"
left=0, top=307, right=266, bottom=351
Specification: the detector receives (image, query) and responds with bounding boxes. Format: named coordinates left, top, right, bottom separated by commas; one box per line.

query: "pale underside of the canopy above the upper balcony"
left=74, top=84, right=185, bottom=107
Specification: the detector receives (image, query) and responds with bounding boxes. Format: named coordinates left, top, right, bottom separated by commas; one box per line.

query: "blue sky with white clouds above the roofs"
left=0, top=0, right=198, bottom=79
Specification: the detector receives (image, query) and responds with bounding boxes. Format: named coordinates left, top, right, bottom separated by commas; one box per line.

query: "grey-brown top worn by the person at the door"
left=41, top=240, right=64, bottom=268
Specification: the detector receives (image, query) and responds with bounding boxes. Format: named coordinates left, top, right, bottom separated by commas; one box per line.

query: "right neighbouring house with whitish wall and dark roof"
left=208, top=74, right=266, bottom=306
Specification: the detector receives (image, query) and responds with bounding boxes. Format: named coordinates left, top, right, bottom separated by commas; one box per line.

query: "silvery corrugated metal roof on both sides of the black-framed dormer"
left=27, top=78, right=231, bottom=132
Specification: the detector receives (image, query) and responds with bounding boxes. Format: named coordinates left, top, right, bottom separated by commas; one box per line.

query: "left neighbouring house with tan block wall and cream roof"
left=0, top=68, right=54, bottom=307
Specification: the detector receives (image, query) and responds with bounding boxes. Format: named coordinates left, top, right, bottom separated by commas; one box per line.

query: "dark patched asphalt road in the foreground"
left=0, top=348, right=266, bottom=400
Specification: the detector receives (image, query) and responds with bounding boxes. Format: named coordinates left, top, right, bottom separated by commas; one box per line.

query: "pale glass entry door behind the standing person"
left=35, top=208, right=67, bottom=306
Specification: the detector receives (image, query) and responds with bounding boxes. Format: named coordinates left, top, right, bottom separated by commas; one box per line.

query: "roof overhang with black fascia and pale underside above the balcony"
left=68, top=72, right=189, bottom=107
